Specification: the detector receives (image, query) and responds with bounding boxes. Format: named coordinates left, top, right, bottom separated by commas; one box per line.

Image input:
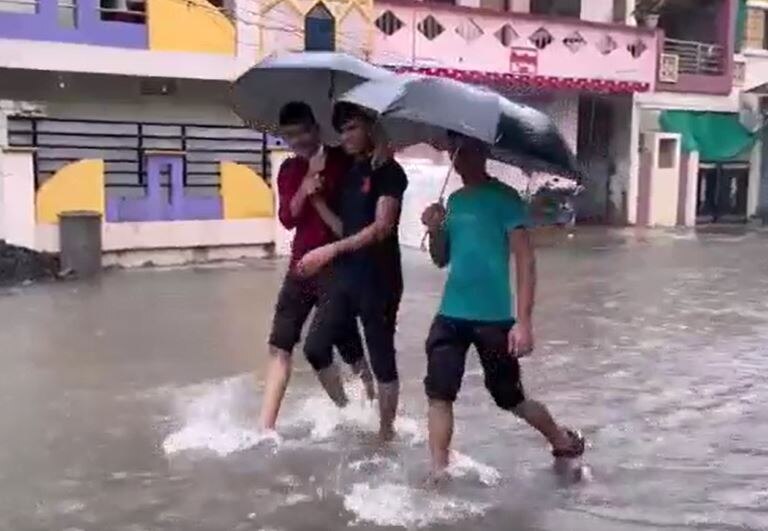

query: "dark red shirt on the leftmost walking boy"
left=277, top=148, right=351, bottom=265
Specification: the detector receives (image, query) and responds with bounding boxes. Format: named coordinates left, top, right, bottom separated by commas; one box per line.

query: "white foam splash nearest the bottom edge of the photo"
left=344, top=483, right=489, bottom=528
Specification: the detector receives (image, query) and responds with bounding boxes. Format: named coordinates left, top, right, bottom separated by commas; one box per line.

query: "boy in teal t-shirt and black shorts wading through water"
left=422, top=136, right=584, bottom=475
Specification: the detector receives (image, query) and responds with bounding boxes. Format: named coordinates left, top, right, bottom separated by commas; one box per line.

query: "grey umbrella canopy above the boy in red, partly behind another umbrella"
left=232, top=52, right=394, bottom=138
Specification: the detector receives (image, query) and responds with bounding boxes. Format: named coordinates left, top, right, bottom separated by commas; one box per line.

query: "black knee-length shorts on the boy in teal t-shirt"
left=424, top=315, right=525, bottom=410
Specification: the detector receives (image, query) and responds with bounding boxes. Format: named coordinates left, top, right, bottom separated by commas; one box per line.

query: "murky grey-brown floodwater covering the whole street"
left=0, top=231, right=768, bottom=531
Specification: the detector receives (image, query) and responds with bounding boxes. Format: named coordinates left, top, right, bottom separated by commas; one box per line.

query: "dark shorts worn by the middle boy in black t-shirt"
left=304, top=279, right=402, bottom=383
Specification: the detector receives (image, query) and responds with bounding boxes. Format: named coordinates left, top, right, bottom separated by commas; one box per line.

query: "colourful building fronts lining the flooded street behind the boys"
left=0, top=0, right=752, bottom=266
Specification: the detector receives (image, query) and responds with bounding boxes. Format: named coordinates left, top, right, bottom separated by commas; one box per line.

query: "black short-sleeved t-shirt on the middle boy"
left=338, top=159, right=408, bottom=290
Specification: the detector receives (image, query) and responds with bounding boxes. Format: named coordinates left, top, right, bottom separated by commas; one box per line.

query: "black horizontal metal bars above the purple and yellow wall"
left=8, top=116, right=270, bottom=194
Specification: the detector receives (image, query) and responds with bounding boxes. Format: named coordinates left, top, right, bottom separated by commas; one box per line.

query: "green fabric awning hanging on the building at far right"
left=659, top=111, right=755, bottom=162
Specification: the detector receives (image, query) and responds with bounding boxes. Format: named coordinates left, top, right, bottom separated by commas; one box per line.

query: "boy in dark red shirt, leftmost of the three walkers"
left=261, top=102, right=373, bottom=430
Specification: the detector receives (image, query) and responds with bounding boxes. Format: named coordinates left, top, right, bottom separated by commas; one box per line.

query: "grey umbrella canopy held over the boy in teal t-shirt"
left=339, top=75, right=579, bottom=176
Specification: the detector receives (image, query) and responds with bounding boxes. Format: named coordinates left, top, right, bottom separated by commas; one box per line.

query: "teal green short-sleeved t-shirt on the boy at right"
left=440, top=179, right=529, bottom=321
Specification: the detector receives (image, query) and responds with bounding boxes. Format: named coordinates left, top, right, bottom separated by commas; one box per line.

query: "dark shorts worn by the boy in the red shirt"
left=269, top=272, right=364, bottom=364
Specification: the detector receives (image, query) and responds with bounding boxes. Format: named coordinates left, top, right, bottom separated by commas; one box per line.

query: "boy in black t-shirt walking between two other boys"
left=297, top=103, right=408, bottom=440
